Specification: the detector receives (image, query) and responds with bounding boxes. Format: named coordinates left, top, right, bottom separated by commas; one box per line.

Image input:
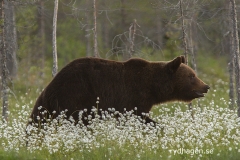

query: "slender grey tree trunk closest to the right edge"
left=230, top=0, right=240, bottom=117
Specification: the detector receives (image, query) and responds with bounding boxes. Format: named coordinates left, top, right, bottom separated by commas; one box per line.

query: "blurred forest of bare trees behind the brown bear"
left=1, top=0, right=239, bottom=118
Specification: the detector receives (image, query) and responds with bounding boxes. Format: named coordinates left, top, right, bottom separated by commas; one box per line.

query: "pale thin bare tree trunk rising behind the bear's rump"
left=52, top=0, right=58, bottom=77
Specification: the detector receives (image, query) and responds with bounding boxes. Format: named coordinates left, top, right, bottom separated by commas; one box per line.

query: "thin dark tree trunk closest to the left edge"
left=0, top=0, right=8, bottom=121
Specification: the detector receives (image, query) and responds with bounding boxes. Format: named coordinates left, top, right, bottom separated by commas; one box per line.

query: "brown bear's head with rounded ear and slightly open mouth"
left=166, top=56, right=210, bottom=102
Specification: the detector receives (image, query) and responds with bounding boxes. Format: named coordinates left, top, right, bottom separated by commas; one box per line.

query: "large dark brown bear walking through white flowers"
left=27, top=56, right=210, bottom=124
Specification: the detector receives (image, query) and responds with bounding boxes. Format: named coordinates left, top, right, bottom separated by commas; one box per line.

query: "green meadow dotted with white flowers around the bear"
left=0, top=54, right=240, bottom=160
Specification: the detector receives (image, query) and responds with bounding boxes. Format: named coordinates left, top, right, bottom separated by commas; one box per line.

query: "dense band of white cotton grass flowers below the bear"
left=0, top=95, right=240, bottom=159
